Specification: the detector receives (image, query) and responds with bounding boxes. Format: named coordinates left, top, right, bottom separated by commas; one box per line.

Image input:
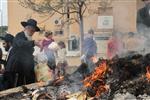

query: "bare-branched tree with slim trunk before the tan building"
left=18, top=0, right=111, bottom=54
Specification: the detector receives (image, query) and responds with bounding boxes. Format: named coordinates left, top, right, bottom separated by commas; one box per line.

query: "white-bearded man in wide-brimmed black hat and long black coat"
left=8, top=19, right=40, bottom=86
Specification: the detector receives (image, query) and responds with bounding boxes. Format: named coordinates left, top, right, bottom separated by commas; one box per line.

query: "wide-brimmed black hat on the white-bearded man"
left=21, top=19, right=40, bottom=32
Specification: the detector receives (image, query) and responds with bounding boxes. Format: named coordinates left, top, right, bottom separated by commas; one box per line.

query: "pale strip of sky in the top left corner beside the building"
left=0, top=0, right=8, bottom=26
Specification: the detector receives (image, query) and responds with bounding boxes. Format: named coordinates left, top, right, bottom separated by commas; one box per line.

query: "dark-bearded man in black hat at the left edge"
left=0, top=34, right=15, bottom=89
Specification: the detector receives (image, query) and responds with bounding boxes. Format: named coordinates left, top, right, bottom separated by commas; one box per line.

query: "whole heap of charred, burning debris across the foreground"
left=0, top=54, right=150, bottom=100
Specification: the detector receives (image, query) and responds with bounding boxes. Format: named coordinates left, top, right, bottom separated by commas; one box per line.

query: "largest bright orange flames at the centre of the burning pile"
left=83, top=61, right=108, bottom=96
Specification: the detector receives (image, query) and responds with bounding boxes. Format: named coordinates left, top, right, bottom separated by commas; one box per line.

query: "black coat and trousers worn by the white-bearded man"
left=6, top=32, right=35, bottom=86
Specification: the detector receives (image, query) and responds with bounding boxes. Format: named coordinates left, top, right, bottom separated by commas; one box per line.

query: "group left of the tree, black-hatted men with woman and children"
left=0, top=19, right=67, bottom=90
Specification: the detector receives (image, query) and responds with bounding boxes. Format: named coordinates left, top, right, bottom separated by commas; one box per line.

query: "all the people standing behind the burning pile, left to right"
left=0, top=19, right=145, bottom=90
